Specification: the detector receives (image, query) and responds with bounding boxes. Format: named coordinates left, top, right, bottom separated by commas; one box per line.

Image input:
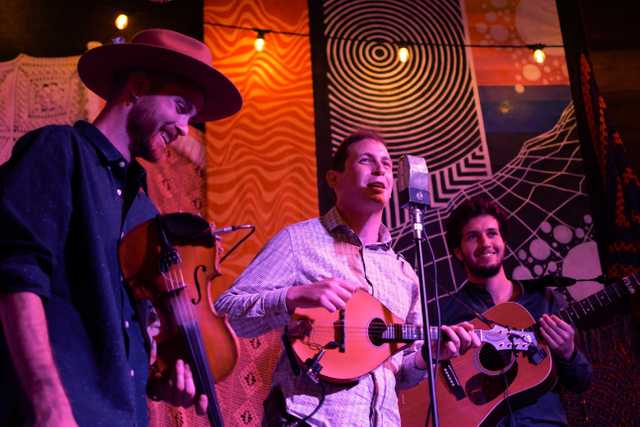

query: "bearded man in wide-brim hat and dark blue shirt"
left=0, top=29, right=242, bottom=426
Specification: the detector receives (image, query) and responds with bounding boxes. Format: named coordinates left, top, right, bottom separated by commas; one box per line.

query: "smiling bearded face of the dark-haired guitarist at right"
left=454, top=215, right=505, bottom=279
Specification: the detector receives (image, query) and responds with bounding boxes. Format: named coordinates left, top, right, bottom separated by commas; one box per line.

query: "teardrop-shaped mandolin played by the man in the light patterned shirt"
left=287, top=290, right=537, bottom=383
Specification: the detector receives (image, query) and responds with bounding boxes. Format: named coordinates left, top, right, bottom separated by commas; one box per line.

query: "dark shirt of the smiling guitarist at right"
left=429, top=280, right=592, bottom=426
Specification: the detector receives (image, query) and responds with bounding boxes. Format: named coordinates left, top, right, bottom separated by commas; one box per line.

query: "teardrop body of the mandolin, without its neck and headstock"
left=289, top=290, right=407, bottom=383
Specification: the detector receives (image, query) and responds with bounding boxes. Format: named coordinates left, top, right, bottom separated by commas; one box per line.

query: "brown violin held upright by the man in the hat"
left=118, top=213, right=238, bottom=427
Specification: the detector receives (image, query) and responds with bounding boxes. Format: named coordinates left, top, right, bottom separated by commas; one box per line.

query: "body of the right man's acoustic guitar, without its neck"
left=426, top=302, right=555, bottom=427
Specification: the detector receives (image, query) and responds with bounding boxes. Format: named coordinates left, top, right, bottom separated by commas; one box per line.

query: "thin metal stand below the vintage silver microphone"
left=409, top=204, right=440, bottom=427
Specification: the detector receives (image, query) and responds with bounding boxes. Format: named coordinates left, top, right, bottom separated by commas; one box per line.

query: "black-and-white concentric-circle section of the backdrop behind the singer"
left=312, top=0, right=491, bottom=212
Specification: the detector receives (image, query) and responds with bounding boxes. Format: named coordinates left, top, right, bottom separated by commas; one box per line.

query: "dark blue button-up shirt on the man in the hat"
left=0, top=122, right=157, bottom=426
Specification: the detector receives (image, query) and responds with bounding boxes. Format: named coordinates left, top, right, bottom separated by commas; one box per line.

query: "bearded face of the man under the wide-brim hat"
left=127, top=76, right=203, bottom=162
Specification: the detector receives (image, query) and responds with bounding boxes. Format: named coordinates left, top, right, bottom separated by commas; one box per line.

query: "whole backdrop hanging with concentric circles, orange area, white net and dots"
left=314, top=0, right=600, bottom=300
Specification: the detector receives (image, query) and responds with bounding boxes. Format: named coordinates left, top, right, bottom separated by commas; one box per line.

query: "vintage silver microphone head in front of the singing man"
left=398, top=154, right=431, bottom=208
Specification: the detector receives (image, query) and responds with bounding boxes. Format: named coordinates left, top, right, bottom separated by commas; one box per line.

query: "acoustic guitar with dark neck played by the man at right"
left=425, top=275, right=640, bottom=427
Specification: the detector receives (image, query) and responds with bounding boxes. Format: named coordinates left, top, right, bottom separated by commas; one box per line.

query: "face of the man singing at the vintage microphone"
left=327, top=138, right=393, bottom=216
